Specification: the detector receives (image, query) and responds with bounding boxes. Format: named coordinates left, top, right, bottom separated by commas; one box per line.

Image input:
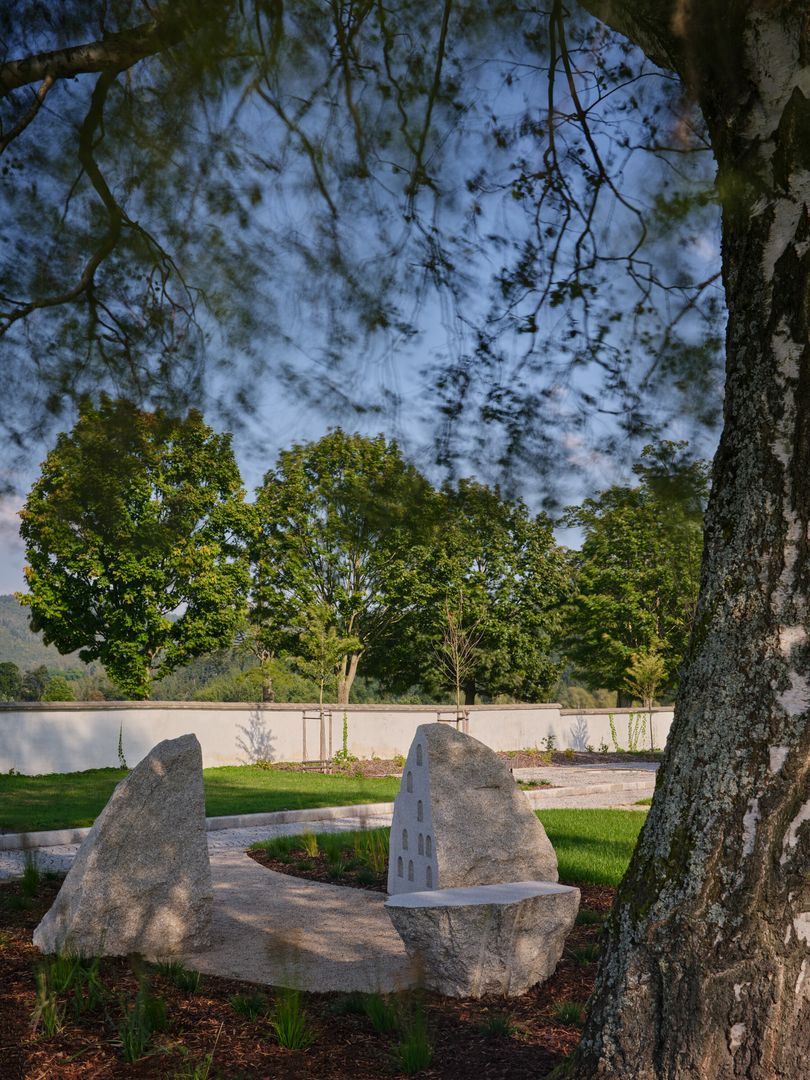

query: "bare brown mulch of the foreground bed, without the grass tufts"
left=0, top=881, right=613, bottom=1080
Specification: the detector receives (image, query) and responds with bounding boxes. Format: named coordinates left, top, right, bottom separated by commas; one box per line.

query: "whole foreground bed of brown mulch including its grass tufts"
left=0, top=877, right=612, bottom=1080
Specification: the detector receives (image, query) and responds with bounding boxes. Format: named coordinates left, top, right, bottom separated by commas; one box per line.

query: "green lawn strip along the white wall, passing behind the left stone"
left=0, top=765, right=400, bottom=833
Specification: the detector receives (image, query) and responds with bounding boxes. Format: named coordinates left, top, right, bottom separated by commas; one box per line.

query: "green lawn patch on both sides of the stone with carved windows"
left=252, top=810, right=647, bottom=886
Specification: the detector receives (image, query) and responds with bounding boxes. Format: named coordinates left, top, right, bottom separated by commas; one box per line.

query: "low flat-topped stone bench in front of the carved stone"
left=386, top=881, right=579, bottom=998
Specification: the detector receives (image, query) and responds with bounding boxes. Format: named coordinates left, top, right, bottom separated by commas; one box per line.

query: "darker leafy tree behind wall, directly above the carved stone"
left=376, top=480, right=569, bottom=704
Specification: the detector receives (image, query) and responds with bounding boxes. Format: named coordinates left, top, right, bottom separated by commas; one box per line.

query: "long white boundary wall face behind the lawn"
left=0, top=701, right=672, bottom=774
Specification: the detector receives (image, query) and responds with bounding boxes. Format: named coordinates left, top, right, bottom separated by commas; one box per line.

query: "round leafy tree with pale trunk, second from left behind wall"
left=253, top=429, right=430, bottom=704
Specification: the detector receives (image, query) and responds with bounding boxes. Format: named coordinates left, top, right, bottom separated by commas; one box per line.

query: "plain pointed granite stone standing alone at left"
left=33, top=734, right=213, bottom=957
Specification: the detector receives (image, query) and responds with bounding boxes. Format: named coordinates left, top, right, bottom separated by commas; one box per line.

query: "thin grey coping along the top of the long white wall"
left=0, top=701, right=565, bottom=714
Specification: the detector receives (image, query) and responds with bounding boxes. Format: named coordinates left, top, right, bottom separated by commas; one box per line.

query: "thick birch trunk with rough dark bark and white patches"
left=563, top=3, right=810, bottom=1080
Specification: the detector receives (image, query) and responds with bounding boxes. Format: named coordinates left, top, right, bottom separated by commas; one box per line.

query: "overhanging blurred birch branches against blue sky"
left=0, top=0, right=723, bottom=487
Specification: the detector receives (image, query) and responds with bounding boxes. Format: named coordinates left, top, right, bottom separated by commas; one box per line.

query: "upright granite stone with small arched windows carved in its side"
left=388, top=724, right=557, bottom=895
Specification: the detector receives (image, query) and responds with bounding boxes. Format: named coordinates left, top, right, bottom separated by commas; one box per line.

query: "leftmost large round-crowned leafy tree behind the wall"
left=19, top=399, right=248, bottom=698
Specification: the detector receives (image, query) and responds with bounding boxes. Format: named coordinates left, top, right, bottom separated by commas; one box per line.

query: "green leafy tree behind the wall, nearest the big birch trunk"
left=566, top=443, right=708, bottom=704
